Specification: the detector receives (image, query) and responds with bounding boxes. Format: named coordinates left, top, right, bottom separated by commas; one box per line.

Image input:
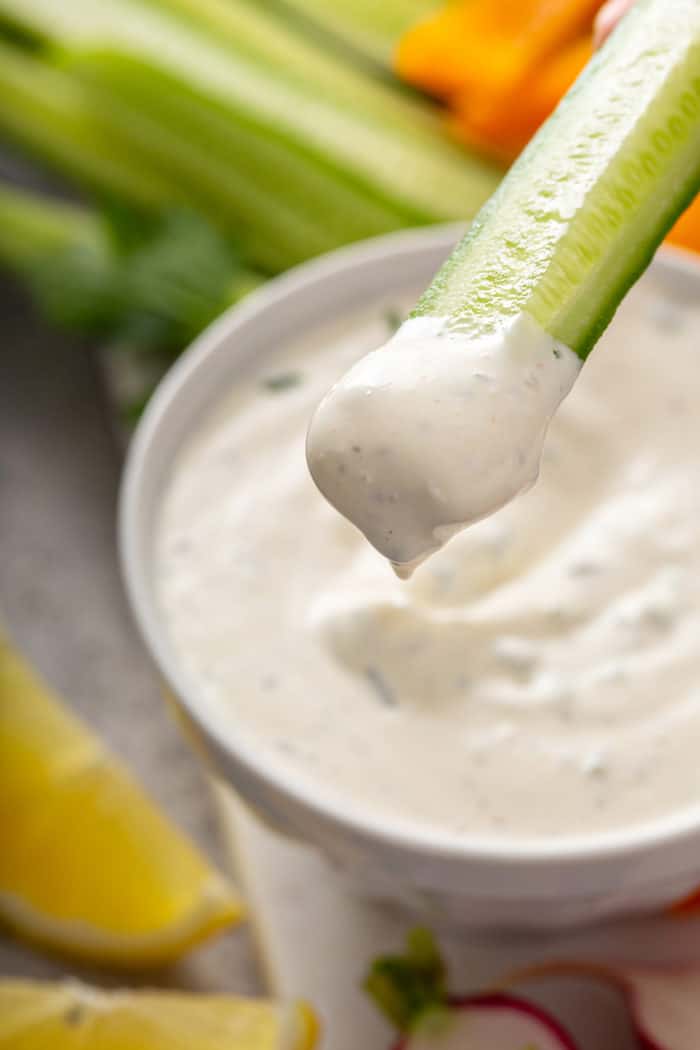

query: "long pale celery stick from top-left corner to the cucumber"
left=0, top=0, right=499, bottom=222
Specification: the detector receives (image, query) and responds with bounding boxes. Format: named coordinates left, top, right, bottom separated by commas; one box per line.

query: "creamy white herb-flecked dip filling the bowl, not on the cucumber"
left=155, top=266, right=700, bottom=839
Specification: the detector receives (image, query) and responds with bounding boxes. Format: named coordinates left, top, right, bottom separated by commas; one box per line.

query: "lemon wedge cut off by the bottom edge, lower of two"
left=0, top=981, right=316, bottom=1050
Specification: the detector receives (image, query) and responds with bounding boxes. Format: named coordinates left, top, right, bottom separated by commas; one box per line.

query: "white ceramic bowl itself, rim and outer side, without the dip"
left=120, top=228, right=700, bottom=927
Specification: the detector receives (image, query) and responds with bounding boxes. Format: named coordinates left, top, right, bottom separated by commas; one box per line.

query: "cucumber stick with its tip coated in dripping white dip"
left=306, top=0, right=700, bottom=575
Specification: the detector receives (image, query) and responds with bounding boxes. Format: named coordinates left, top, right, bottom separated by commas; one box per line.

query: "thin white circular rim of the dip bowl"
left=118, top=224, right=700, bottom=869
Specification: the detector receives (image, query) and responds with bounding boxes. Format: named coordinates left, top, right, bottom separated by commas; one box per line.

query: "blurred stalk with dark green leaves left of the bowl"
left=0, top=179, right=261, bottom=360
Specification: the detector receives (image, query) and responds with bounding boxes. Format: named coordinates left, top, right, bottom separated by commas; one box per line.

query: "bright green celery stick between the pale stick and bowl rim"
left=69, top=53, right=413, bottom=270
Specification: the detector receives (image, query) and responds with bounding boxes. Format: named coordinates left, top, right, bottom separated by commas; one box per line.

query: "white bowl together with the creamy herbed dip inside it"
left=120, top=228, right=700, bottom=927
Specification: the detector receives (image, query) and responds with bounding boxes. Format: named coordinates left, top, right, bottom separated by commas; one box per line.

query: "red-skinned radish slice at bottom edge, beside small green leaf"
left=396, top=994, right=579, bottom=1050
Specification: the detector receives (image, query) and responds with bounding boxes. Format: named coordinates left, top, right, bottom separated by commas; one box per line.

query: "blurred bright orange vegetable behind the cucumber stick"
left=396, top=0, right=700, bottom=251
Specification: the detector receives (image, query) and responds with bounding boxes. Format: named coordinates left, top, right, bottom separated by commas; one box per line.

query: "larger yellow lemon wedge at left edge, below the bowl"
left=0, top=635, right=242, bottom=965
